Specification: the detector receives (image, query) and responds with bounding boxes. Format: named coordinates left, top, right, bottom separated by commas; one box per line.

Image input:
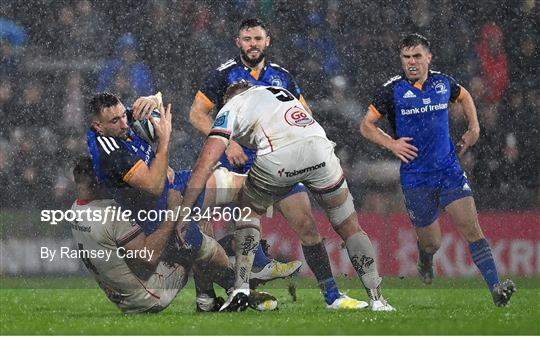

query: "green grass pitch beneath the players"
left=0, top=278, right=540, bottom=335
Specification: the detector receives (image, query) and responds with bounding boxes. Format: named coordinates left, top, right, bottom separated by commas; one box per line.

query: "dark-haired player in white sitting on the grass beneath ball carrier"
left=71, top=157, right=275, bottom=314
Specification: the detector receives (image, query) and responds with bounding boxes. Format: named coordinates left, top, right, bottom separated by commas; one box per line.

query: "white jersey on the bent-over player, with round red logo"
left=208, top=86, right=326, bottom=155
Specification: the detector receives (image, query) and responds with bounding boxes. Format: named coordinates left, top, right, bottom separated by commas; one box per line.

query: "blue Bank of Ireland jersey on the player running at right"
left=369, top=71, right=461, bottom=186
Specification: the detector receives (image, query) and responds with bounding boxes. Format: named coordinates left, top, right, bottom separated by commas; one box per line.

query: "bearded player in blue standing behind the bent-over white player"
left=179, top=19, right=360, bottom=308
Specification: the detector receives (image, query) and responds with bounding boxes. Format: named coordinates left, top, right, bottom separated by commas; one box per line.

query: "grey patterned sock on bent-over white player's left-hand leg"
left=234, top=226, right=261, bottom=289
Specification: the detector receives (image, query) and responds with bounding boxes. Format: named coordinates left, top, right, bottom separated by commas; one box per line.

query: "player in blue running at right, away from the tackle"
left=360, top=34, right=515, bottom=306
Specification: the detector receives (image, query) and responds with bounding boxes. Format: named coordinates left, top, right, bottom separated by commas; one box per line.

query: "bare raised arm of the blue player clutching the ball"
left=126, top=104, right=172, bottom=196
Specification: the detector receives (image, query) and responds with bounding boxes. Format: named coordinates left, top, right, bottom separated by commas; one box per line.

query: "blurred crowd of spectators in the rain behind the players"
left=0, top=0, right=540, bottom=212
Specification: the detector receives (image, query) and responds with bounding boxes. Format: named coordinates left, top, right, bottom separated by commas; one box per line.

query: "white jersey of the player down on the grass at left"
left=71, top=199, right=163, bottom=313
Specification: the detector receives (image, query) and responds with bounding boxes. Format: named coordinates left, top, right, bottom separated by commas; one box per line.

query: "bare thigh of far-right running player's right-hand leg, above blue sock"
left=446, top=196, right=484, bottom=243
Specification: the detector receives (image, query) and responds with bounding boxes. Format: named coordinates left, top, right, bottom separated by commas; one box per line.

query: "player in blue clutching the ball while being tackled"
left=87, top=93, right=282, bottom=312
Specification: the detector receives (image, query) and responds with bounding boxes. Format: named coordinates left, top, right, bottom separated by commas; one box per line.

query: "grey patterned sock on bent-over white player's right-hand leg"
left=345, top=231, right=382, bottom=300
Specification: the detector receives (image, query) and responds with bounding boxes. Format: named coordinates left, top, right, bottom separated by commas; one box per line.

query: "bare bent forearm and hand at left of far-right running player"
left=360, top=109, right=418, bottom=163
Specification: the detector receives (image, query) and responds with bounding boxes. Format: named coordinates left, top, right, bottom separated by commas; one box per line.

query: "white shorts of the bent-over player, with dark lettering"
left=243, top=136, right=345, bottom=212
